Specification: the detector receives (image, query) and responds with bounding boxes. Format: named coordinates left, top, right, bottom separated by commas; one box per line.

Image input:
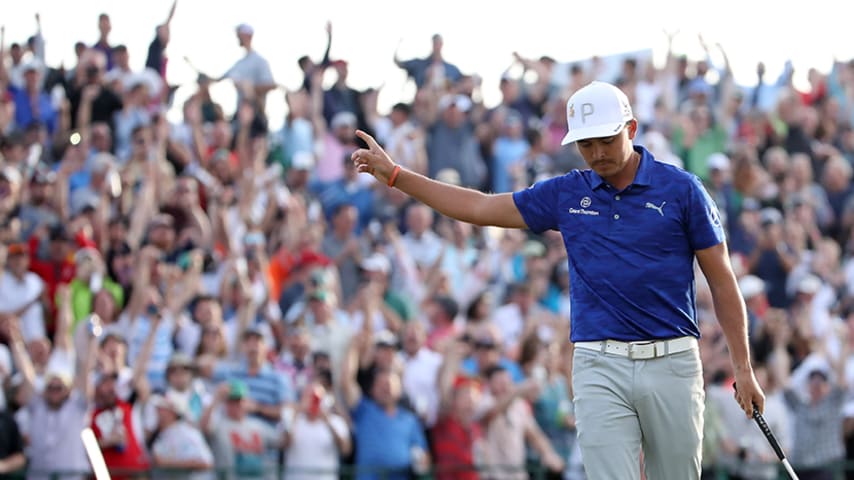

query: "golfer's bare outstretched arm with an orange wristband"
left=351, top=130, right=527, bottom=228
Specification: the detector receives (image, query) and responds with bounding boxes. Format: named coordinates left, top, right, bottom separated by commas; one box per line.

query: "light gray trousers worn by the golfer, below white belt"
left=572, top=348, right=705, bottom=480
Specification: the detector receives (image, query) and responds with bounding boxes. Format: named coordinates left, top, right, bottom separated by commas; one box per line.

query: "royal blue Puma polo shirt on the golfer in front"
left=513, top=146, right=725, bottom=342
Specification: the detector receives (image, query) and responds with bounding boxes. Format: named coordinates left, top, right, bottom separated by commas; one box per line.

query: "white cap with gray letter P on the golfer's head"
left=561, top=81, right=634, bottom=145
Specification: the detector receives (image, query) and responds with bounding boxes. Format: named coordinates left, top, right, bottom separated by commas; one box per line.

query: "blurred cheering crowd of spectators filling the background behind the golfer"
left=0, top=1, right=854, bottom=479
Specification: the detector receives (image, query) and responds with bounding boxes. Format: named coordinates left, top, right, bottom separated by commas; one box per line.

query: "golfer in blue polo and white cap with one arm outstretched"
left=351, top=82, right=765, bottom=480
